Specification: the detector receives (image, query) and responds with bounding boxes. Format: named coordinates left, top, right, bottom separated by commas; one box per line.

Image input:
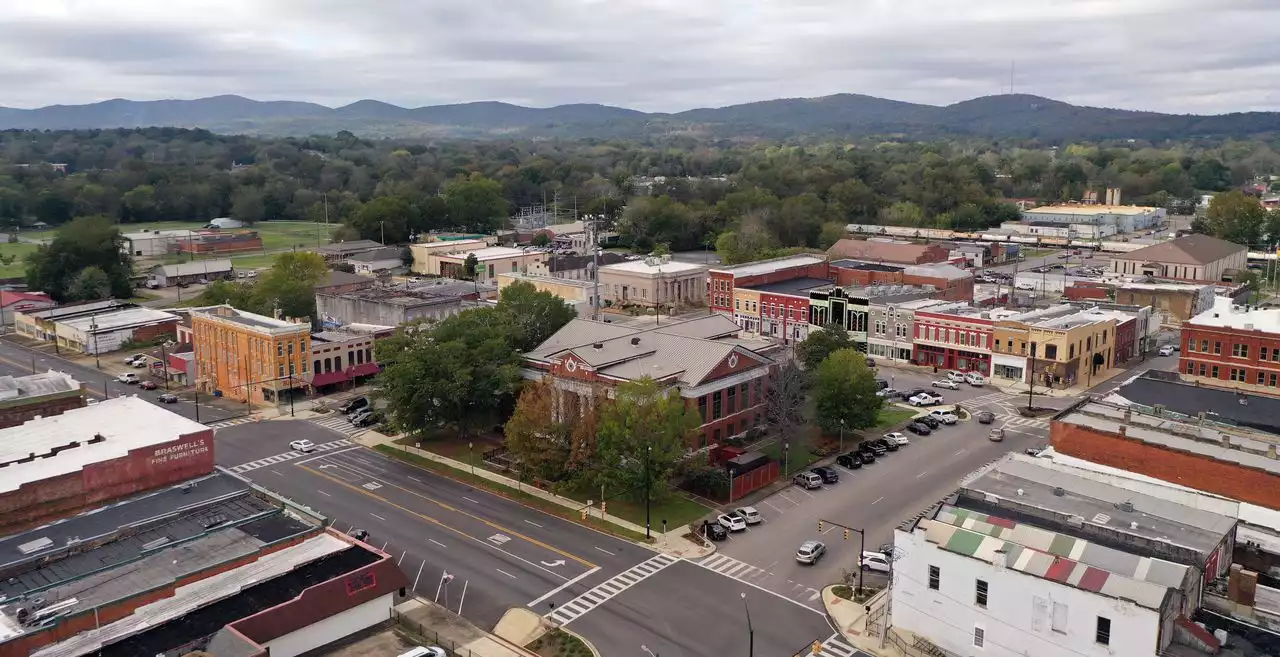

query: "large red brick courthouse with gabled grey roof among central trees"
left=525, top=315, right=776, bottom=448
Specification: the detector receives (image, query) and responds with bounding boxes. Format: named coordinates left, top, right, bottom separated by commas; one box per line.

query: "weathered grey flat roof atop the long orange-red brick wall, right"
left=1053, top=399, right=1280, bottom=474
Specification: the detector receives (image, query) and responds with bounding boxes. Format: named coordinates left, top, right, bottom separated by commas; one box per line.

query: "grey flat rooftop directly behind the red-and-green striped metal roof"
left=960, top=453, right=1235, bottom=558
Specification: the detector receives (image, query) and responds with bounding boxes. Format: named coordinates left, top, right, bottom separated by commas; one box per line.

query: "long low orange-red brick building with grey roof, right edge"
left=1050, top=400, right=1280, bottom=510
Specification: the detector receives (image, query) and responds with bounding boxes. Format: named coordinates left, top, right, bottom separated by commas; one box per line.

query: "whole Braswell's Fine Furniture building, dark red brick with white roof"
left=0, top=397, right=214, bottom=530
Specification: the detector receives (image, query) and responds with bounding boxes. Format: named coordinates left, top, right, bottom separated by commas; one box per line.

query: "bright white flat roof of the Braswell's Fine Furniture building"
left=0, top=396, right=212, bottom=493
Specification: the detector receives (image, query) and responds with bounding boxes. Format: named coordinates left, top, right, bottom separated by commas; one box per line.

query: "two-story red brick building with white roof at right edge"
left=1178, top=297, right=1280, bottom=394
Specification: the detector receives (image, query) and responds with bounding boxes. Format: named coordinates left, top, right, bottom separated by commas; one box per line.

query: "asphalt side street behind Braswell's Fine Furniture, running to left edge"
left=0, top=338, right=246, bottom=424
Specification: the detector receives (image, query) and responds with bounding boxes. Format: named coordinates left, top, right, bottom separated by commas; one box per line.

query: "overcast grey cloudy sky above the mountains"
left=0, top=0, right=1280, bottom=113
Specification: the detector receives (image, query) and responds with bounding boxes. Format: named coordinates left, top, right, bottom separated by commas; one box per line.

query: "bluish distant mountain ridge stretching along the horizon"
left=0, top=93, right=1280, bottom=141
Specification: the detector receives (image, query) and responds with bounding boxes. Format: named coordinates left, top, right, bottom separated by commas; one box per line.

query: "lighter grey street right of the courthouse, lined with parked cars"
left=696, top=368, right=1047, bottom=610
